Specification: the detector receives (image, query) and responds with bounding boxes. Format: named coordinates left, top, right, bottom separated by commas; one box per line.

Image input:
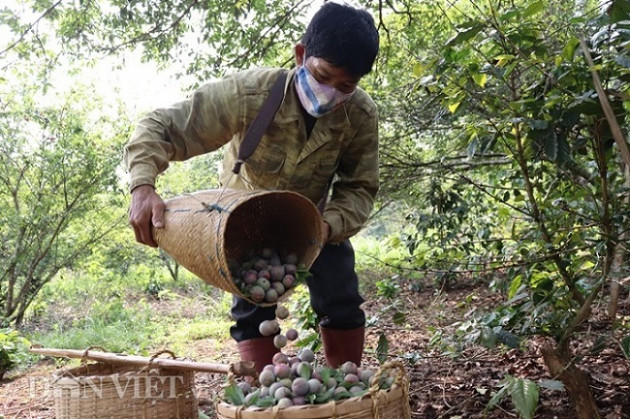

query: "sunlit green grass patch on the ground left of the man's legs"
left=22, top=275, right=237, bottom=355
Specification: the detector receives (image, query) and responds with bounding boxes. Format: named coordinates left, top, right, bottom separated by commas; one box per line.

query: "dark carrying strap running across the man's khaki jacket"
left=232, top=71, right=287, bottom=174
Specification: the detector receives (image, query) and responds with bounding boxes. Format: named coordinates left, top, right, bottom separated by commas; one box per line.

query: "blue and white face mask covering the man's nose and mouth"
left=295, top=65, right=354, bottom=118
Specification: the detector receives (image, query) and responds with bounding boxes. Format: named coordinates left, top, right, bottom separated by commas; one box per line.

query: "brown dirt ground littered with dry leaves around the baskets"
left=0, top=280, right=630, bottom=419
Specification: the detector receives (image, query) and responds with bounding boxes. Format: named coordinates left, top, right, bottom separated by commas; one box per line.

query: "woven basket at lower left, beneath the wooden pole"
left=51, top=352, right=199, bottom=419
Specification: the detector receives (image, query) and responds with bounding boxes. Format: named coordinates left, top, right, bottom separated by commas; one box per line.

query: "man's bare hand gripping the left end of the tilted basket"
left=129, top=185, right=166, bottom=247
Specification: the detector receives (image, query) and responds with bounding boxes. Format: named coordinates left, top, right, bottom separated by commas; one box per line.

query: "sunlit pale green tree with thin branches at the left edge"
left=0, top=64, right=125, bottom=325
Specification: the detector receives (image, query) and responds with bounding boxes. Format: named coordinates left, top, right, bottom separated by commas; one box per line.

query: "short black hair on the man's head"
left=302, top=3, right=379, bottom=77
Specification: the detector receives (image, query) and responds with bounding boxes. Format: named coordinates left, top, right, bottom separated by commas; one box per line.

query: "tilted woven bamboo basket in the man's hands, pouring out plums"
left=153, top=189, right=324, bottom=305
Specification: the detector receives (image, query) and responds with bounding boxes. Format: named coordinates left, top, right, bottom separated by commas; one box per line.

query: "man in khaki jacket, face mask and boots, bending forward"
left=125, top=3, right=379, bottom=371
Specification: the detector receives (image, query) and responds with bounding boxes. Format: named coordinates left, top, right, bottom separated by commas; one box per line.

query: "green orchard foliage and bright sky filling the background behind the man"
left=0, top=0, right=630, bottom=413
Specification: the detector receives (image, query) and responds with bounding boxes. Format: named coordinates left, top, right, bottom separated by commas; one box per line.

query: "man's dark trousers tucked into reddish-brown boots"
left=230, top=240, right=365, bottom=342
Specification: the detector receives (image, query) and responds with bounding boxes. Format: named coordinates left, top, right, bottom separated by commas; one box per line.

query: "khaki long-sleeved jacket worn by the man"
left=125, top=69, right=379, bottom=242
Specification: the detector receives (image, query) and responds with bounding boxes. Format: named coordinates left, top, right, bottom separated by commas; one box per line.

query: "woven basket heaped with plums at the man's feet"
left=216, top=362, right=411, bottom=419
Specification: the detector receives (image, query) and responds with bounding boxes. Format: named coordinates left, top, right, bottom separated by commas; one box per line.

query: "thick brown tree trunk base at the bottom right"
left=541, top=345, right=600, bottom=419
